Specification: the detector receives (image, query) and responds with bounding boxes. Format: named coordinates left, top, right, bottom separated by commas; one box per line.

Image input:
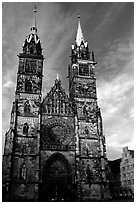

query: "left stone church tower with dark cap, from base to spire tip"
left=3, top=8, right=44, bottom=201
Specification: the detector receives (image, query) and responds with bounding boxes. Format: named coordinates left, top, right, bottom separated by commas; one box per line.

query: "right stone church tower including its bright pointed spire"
left=68, top=16, right=106, bottom=201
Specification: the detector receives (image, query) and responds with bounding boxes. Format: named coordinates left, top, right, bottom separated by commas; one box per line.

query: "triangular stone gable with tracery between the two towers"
left=42, top=79, right=73, bottom=116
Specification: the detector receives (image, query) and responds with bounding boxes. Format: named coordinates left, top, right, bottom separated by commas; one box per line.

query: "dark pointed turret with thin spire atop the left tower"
left=23, top=6, right=42, bottom=55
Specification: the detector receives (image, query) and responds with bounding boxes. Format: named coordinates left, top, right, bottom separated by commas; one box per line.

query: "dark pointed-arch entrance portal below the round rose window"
left=42, top=153, right=73, bottom=201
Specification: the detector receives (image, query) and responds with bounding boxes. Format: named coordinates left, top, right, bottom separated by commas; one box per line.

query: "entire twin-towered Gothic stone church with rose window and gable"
left=3, top=10, right=109, bottom=201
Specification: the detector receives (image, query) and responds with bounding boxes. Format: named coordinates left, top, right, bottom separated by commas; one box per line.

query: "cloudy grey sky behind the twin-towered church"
left=2, top=2, right=134, bottom=159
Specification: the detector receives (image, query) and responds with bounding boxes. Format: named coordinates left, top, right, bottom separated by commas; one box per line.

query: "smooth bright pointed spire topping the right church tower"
left=76, top=15, right=85, bottom=46
